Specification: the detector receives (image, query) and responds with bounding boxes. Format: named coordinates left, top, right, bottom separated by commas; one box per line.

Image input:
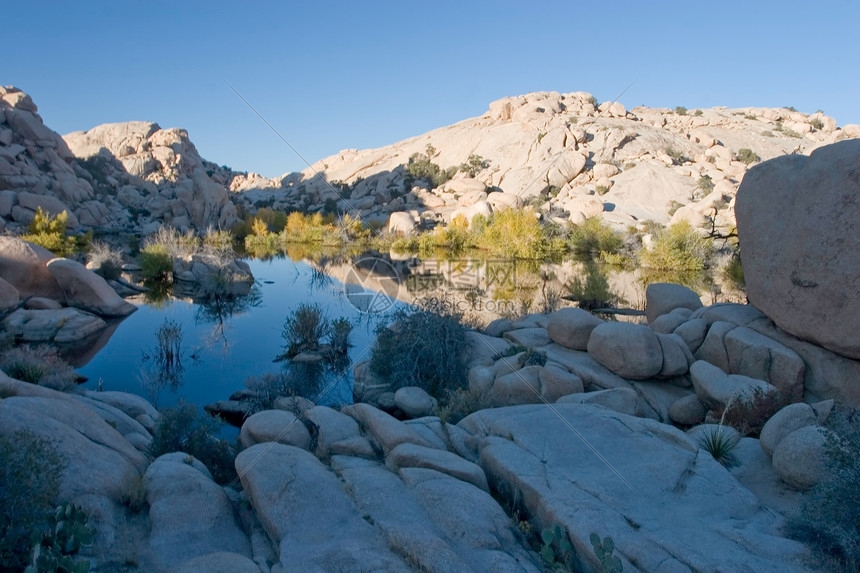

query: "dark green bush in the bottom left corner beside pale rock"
left=0, top=430, right=63, bottom=572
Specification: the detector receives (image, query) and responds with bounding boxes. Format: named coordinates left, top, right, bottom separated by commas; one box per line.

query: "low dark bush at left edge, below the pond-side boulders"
left=0, top=344, right=78, bottom=391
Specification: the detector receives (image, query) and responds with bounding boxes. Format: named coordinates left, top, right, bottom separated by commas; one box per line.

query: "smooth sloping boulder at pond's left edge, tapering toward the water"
left=47, top=258, right=137, bottom=317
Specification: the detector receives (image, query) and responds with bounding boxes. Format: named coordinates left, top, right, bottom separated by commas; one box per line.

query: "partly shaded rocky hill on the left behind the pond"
left=0, top=87, right=236, bottom=233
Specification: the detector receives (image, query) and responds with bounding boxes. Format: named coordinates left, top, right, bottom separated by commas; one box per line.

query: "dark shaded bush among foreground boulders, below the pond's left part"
left=149, top=400, right=236, bottom=485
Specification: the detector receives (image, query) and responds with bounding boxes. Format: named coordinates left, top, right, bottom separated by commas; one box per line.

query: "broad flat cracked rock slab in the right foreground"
left=460, top=404, right=806, bottom=573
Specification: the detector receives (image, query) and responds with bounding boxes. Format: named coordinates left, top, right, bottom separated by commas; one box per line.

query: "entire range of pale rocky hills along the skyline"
left=0, top=87, right=860, bottom=234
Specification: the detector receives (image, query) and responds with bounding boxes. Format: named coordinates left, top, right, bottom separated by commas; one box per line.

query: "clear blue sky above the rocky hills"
left=0, top=0, right=860, bottom=177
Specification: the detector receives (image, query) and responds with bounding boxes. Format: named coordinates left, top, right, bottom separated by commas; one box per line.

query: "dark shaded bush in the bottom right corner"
left=788, top=405, right=860, bottom=572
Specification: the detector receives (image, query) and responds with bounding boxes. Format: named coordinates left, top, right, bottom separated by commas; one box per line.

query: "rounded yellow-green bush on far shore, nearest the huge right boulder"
left=639, top=221, right=713, bottom=271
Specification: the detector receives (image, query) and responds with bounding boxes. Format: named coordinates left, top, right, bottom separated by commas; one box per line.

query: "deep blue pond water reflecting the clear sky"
left=79, top=259, right=401, bottom=407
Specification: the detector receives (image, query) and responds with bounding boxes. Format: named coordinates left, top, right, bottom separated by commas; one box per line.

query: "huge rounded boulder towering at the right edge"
left=735, top=139, right=860, bottom=359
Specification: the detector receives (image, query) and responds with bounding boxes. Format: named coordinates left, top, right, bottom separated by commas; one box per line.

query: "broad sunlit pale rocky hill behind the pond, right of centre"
left=243, top=92, right=860, bottom=230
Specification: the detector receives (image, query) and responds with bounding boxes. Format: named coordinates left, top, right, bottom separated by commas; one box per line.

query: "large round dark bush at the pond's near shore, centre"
left=370, top=310, right=467, bottom=397
